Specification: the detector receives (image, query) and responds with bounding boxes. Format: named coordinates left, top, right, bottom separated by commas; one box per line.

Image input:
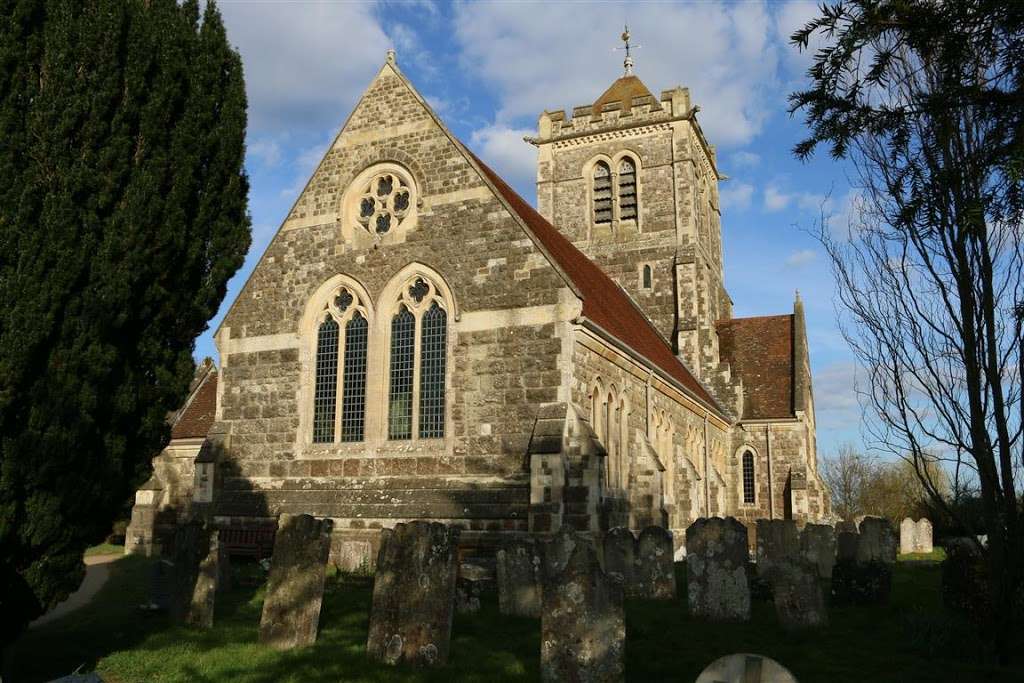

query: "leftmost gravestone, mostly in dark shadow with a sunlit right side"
left=170, top=520, right=220, bottom=629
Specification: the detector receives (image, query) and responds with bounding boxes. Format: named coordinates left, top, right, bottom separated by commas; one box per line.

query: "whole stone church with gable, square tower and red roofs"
left=129, top=46, right=829, bottom=565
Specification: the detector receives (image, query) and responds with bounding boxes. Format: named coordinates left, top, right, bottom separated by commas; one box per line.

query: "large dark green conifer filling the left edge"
left=0, top=0, right=250, bottom=641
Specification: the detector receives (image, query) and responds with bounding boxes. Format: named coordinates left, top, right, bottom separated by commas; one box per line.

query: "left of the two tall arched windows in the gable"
left=300, top=275, right=373, bottom=443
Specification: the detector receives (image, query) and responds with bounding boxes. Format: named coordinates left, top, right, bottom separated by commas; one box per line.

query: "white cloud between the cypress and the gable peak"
left=219, top=2, right=391, bottom=133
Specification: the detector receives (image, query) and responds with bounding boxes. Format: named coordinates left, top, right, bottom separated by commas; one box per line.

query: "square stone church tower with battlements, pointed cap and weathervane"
left=528, top=29, right=732, bottom=385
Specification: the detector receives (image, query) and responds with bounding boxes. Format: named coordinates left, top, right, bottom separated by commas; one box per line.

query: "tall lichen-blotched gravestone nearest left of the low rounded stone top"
left=541, top=527, right=626, bottom=683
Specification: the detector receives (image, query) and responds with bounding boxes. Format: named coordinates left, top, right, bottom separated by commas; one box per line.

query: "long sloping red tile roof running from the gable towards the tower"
left=470, top=153, right=721, bottom=413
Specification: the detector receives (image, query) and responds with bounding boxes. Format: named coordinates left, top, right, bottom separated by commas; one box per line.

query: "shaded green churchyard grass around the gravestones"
left=3, top=557, right=1024, bottom=683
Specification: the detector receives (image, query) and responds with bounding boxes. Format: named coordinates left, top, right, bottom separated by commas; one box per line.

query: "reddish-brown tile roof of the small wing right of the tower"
left=716, top=314, right=794, bottom=420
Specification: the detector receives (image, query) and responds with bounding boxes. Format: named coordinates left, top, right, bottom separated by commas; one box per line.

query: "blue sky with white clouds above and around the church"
left=196, top=0, right=860, bottom=455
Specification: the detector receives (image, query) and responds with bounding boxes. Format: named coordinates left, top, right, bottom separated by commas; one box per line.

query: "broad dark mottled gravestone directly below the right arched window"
left=367, top=520, right=459, bottom=666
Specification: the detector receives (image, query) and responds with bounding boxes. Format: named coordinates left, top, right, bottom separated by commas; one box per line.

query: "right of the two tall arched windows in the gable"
left=380, top=267, right=455, bottom=441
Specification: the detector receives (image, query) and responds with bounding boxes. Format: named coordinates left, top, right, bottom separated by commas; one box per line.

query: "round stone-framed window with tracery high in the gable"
left=341, top=162, right=420, bottom=248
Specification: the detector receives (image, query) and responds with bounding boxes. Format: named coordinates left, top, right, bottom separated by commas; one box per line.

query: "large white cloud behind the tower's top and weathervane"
left=455, top=2, right=781, bottom=145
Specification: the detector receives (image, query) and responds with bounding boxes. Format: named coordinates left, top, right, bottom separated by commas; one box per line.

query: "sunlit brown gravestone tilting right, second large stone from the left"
left=259, top=514, right=334, bottom=650
